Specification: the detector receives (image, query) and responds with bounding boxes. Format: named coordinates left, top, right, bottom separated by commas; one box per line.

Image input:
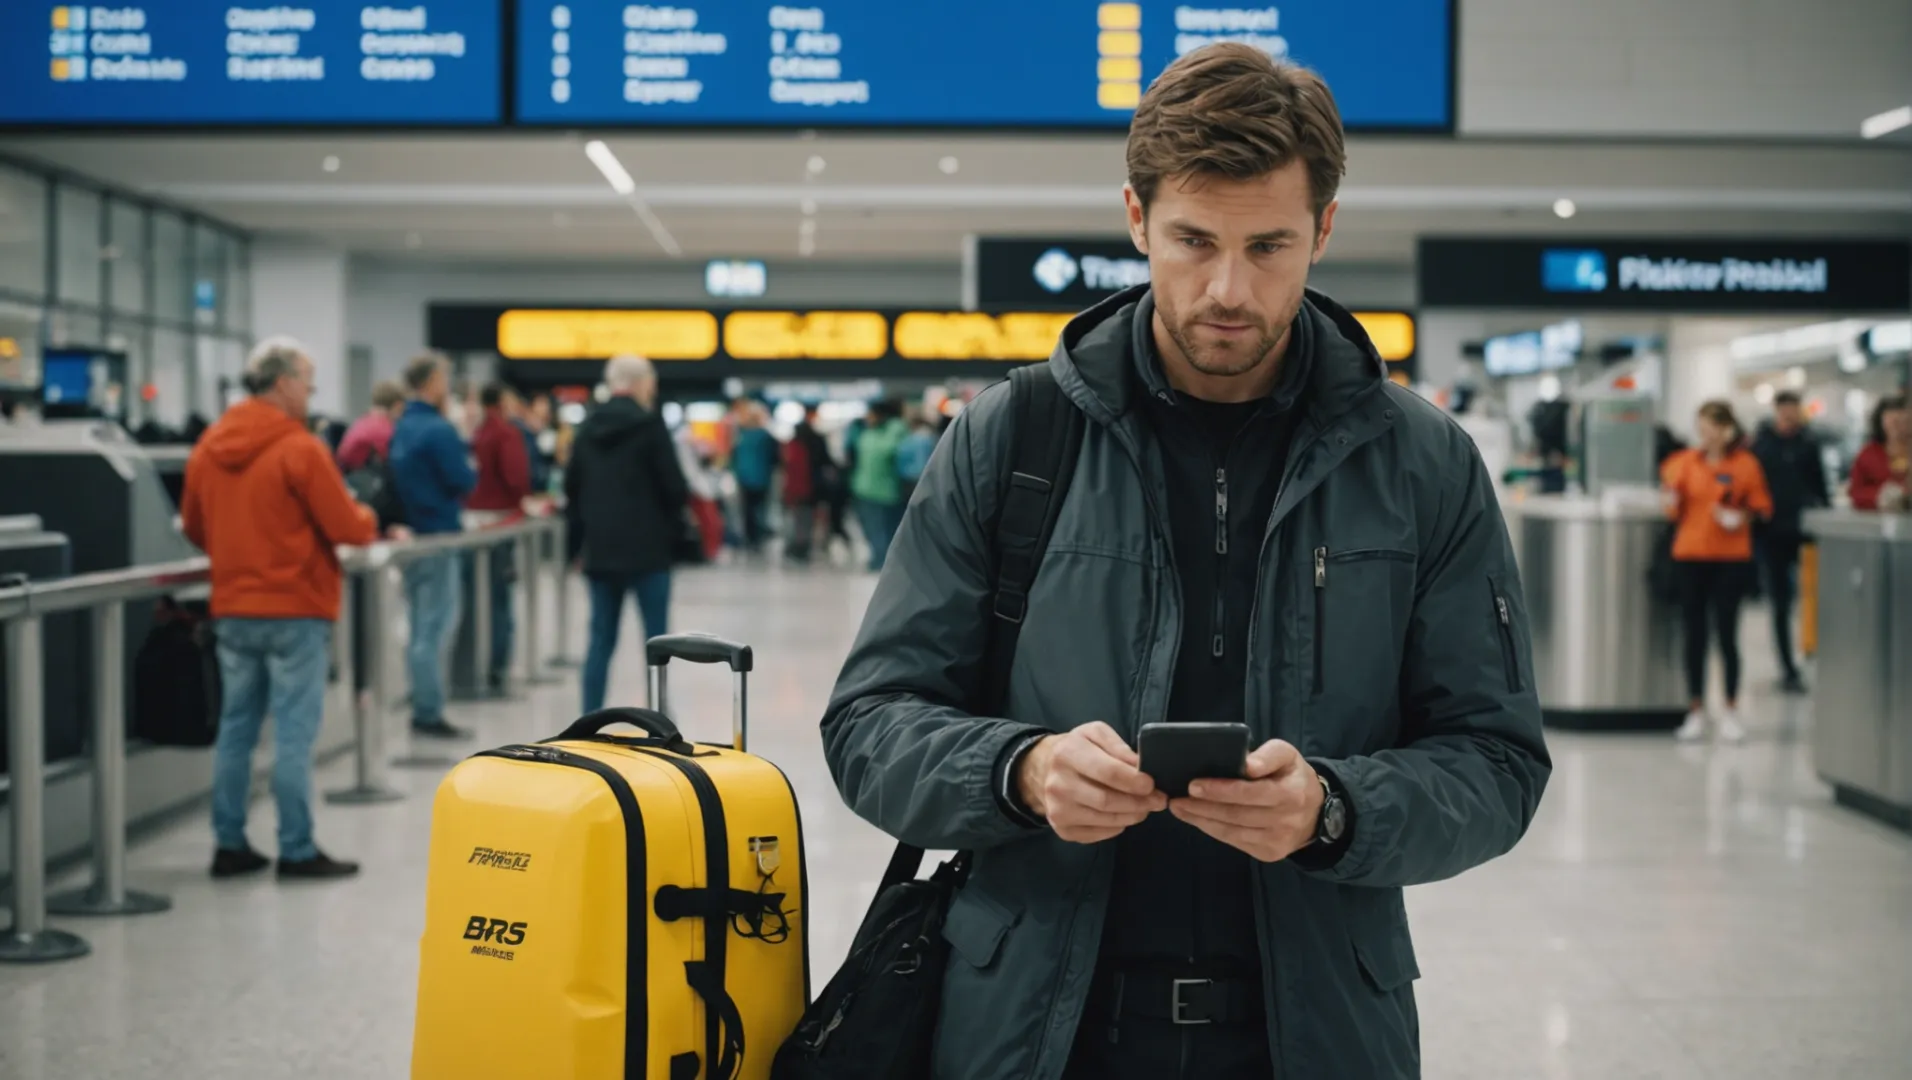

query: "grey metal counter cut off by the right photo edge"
left=1805, top=510, right=1912, bottom=830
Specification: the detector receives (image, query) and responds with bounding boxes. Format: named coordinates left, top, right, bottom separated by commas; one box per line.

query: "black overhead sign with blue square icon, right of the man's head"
left=1419, top=239, right=1912, bottom=313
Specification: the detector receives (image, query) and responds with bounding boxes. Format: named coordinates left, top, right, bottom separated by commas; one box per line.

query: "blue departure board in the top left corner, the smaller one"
left=0, top=0, right=505, bottom=126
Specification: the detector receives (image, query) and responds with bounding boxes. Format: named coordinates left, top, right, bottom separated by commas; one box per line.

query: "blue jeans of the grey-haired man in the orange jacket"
left=212, top=619, right=333, bottom=862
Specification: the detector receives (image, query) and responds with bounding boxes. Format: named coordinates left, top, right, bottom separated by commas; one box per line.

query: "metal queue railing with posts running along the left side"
left=0, top=514, right=570, bottom=963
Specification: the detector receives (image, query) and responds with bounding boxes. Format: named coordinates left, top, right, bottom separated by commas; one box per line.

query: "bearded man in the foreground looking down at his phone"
left=822, top=44, right=1551, bottom=1080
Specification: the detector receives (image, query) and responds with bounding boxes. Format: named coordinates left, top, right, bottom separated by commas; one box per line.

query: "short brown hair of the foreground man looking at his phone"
left=1128, top=42, right=1348, bottom=222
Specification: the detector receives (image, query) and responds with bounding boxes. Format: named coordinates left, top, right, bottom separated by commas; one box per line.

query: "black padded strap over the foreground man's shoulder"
left=983, top=363, right=1086, bottom=711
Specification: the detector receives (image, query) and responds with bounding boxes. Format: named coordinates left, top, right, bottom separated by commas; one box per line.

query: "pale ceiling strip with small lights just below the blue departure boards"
left=0, top=132, right=1912, bottom=264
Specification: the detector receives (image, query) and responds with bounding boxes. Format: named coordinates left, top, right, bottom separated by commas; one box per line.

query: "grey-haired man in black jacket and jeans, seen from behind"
left=564, top=356, right=688, bottom=713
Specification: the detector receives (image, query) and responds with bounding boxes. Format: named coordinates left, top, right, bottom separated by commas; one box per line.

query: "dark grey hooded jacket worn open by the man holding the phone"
left=822, top=289, right=1551, bottom=1080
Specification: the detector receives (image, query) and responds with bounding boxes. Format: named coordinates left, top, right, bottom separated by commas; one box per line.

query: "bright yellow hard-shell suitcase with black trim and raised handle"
left=411, top=635, right=809, bottom=1080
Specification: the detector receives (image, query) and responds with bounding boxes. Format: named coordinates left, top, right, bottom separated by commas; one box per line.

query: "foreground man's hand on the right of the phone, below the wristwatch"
left=1168, top=740, right=1321, bottom=862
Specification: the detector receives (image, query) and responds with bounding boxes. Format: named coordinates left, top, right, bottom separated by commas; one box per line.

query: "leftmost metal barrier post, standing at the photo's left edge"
left=0, top=616, right=92, bottom=963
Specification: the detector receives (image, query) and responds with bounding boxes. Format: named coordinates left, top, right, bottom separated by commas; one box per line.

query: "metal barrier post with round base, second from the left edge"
left=46, top=600, right=172, bottom=916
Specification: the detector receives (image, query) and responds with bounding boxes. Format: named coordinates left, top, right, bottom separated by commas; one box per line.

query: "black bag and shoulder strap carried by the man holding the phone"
left=771, top=363, right=1088, bottom=1080
